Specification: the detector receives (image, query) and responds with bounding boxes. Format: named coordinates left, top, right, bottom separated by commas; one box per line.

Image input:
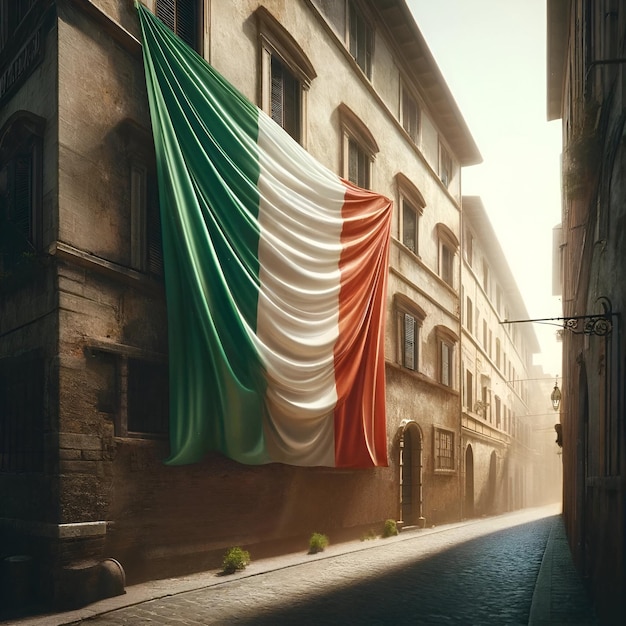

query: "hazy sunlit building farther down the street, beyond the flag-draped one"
left=461, top=196, right=560, bottom=517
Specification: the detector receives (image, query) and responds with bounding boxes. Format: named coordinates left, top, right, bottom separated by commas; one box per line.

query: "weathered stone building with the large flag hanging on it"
left=0, top=0, right=534, bottom=602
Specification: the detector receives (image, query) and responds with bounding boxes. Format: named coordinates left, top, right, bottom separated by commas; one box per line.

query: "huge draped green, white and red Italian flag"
left=137, top=4, right=392, bottom=468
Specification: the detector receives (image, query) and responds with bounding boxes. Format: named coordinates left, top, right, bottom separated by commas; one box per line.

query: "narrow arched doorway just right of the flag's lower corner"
left=399, top=422, right=422, bottom=526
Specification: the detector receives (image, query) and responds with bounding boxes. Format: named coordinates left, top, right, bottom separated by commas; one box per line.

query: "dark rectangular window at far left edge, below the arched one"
left=0, top=355, right=44, bottom=472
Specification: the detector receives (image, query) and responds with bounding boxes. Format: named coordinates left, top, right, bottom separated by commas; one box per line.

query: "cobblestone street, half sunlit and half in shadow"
left=56, top=509, right=555, bottom=626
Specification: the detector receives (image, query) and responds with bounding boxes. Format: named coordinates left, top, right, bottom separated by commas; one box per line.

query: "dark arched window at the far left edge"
left=0, top=111, right=44, bottom=274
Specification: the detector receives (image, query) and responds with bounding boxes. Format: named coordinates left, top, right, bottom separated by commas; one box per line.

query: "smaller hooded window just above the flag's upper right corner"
left=339, top=104, right=378, bottom=189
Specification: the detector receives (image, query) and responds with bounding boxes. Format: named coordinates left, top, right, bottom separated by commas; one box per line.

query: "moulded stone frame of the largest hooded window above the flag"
left=255, top=6, right=317, bottom=147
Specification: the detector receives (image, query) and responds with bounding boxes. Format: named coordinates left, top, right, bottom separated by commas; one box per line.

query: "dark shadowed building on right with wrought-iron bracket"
left=547, top=0, right=626, bottom=624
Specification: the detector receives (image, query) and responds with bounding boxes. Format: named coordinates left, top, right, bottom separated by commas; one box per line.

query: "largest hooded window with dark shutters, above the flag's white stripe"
left=256, top=7, right=317, bottom=145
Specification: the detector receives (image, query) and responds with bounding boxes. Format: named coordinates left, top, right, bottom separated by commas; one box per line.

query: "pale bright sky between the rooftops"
left=407, top=0, right=562, bottom=374
